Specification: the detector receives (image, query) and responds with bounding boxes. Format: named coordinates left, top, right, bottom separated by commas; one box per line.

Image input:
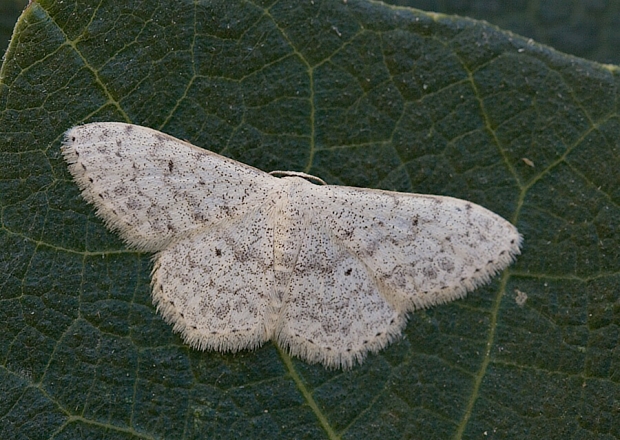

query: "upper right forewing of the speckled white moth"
left=308, top=185, right=521, bottom=312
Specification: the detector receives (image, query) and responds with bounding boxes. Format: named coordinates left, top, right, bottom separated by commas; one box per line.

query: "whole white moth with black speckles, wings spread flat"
left=62, top=122, right=521, bottom=368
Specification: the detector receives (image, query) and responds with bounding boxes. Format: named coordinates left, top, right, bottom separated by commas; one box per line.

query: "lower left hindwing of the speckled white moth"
left=152, top=204, right=274, bottom=352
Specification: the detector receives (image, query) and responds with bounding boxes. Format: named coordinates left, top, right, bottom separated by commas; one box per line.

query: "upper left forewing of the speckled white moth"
left=62, top=122, right=279, bottom=251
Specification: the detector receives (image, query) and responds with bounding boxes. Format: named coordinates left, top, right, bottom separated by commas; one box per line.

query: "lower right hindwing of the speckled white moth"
left=276, top=218, right=406, bottom=368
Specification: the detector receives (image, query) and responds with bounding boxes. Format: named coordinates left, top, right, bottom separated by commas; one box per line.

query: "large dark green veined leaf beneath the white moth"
left=0, top=0, right=620, bottom=439
